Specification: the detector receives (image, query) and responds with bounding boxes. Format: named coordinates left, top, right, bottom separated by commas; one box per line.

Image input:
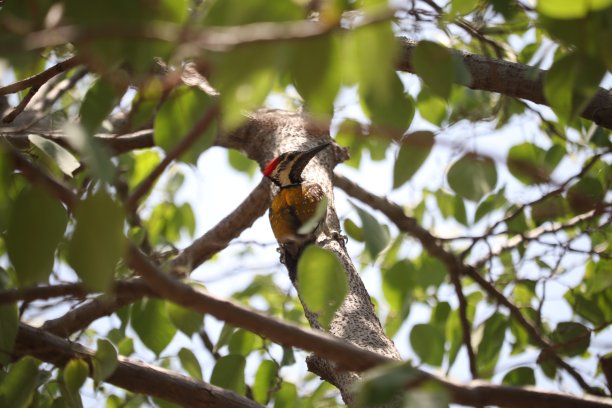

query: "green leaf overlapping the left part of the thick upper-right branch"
left=412, top=41, right=455, bottom=99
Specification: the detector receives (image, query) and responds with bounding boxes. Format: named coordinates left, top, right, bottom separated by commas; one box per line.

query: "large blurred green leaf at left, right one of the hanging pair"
left=68, top=189, right=125, bottom=291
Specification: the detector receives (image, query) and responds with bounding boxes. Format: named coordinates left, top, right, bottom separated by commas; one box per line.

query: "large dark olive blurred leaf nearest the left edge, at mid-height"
left=6, top=186, right=68, bottom=286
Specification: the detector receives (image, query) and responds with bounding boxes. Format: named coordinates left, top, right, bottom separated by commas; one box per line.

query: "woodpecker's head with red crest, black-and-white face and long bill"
left=264, top=143, right=330, bottom=187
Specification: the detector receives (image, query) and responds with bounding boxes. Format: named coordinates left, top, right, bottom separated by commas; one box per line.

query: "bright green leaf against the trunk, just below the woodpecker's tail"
left=297, top=245, right=348, bottom=329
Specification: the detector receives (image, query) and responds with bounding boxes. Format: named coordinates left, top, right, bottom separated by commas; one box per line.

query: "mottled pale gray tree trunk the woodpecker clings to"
left=217, top=110, right=399, bottom=403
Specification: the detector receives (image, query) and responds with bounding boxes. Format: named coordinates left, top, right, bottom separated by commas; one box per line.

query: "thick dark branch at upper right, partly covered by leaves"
left=398, top=39, right=612, bottom=129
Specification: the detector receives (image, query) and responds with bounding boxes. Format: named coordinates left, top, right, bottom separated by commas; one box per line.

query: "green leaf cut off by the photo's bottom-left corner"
left=0, top=356, right=39, bottom=408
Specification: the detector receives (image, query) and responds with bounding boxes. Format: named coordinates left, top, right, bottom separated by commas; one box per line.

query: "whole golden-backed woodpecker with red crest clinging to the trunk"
left=263, top=143, right=330, bottom=282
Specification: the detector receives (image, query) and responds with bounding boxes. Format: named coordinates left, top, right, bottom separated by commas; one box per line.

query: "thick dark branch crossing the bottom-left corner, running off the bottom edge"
left=15, top=323, right=261, bottom=408
